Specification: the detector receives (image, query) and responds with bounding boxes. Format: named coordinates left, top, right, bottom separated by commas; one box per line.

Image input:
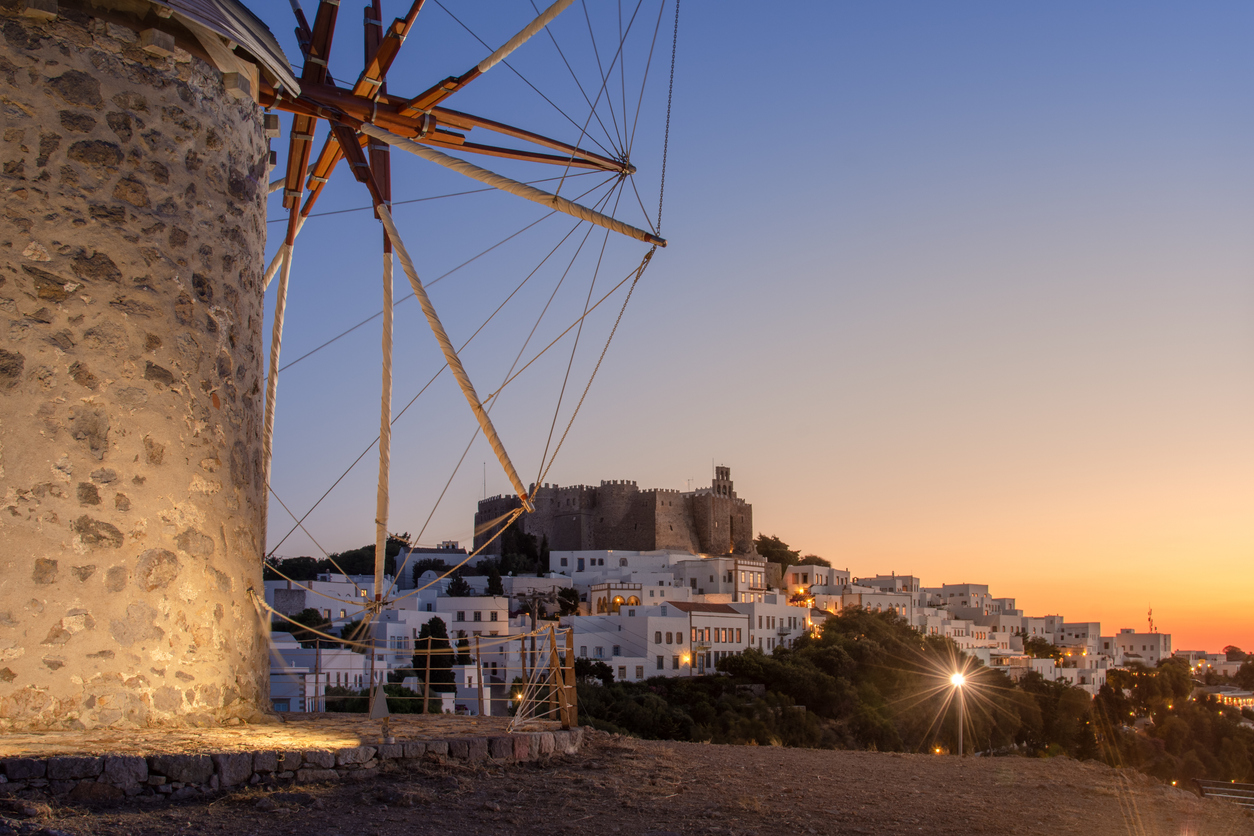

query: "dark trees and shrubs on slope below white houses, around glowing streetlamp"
left=579, top=608, right=1254, bottom=782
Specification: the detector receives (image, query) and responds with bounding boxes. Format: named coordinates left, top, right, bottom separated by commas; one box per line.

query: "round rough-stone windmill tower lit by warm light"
left=0, top=4, right=268, bottom=729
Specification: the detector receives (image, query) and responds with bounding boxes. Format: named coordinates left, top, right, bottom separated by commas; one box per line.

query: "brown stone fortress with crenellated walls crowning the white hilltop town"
left=474, top=466, right=754, bottom=554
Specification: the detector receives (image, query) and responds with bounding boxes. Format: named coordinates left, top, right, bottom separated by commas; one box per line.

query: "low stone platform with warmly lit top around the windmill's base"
left=0, top=714, right=584, bottom=803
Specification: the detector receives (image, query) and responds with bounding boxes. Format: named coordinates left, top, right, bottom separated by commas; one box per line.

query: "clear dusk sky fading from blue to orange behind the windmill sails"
left=253, top=0, right=1254, bottom=651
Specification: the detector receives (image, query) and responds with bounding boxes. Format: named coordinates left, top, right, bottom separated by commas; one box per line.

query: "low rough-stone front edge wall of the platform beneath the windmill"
left=0, top=728, right=583, bottom=803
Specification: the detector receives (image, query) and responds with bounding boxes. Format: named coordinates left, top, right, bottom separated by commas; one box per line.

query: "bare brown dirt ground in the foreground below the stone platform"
left=0, top=729, right=1254, bottom=836
